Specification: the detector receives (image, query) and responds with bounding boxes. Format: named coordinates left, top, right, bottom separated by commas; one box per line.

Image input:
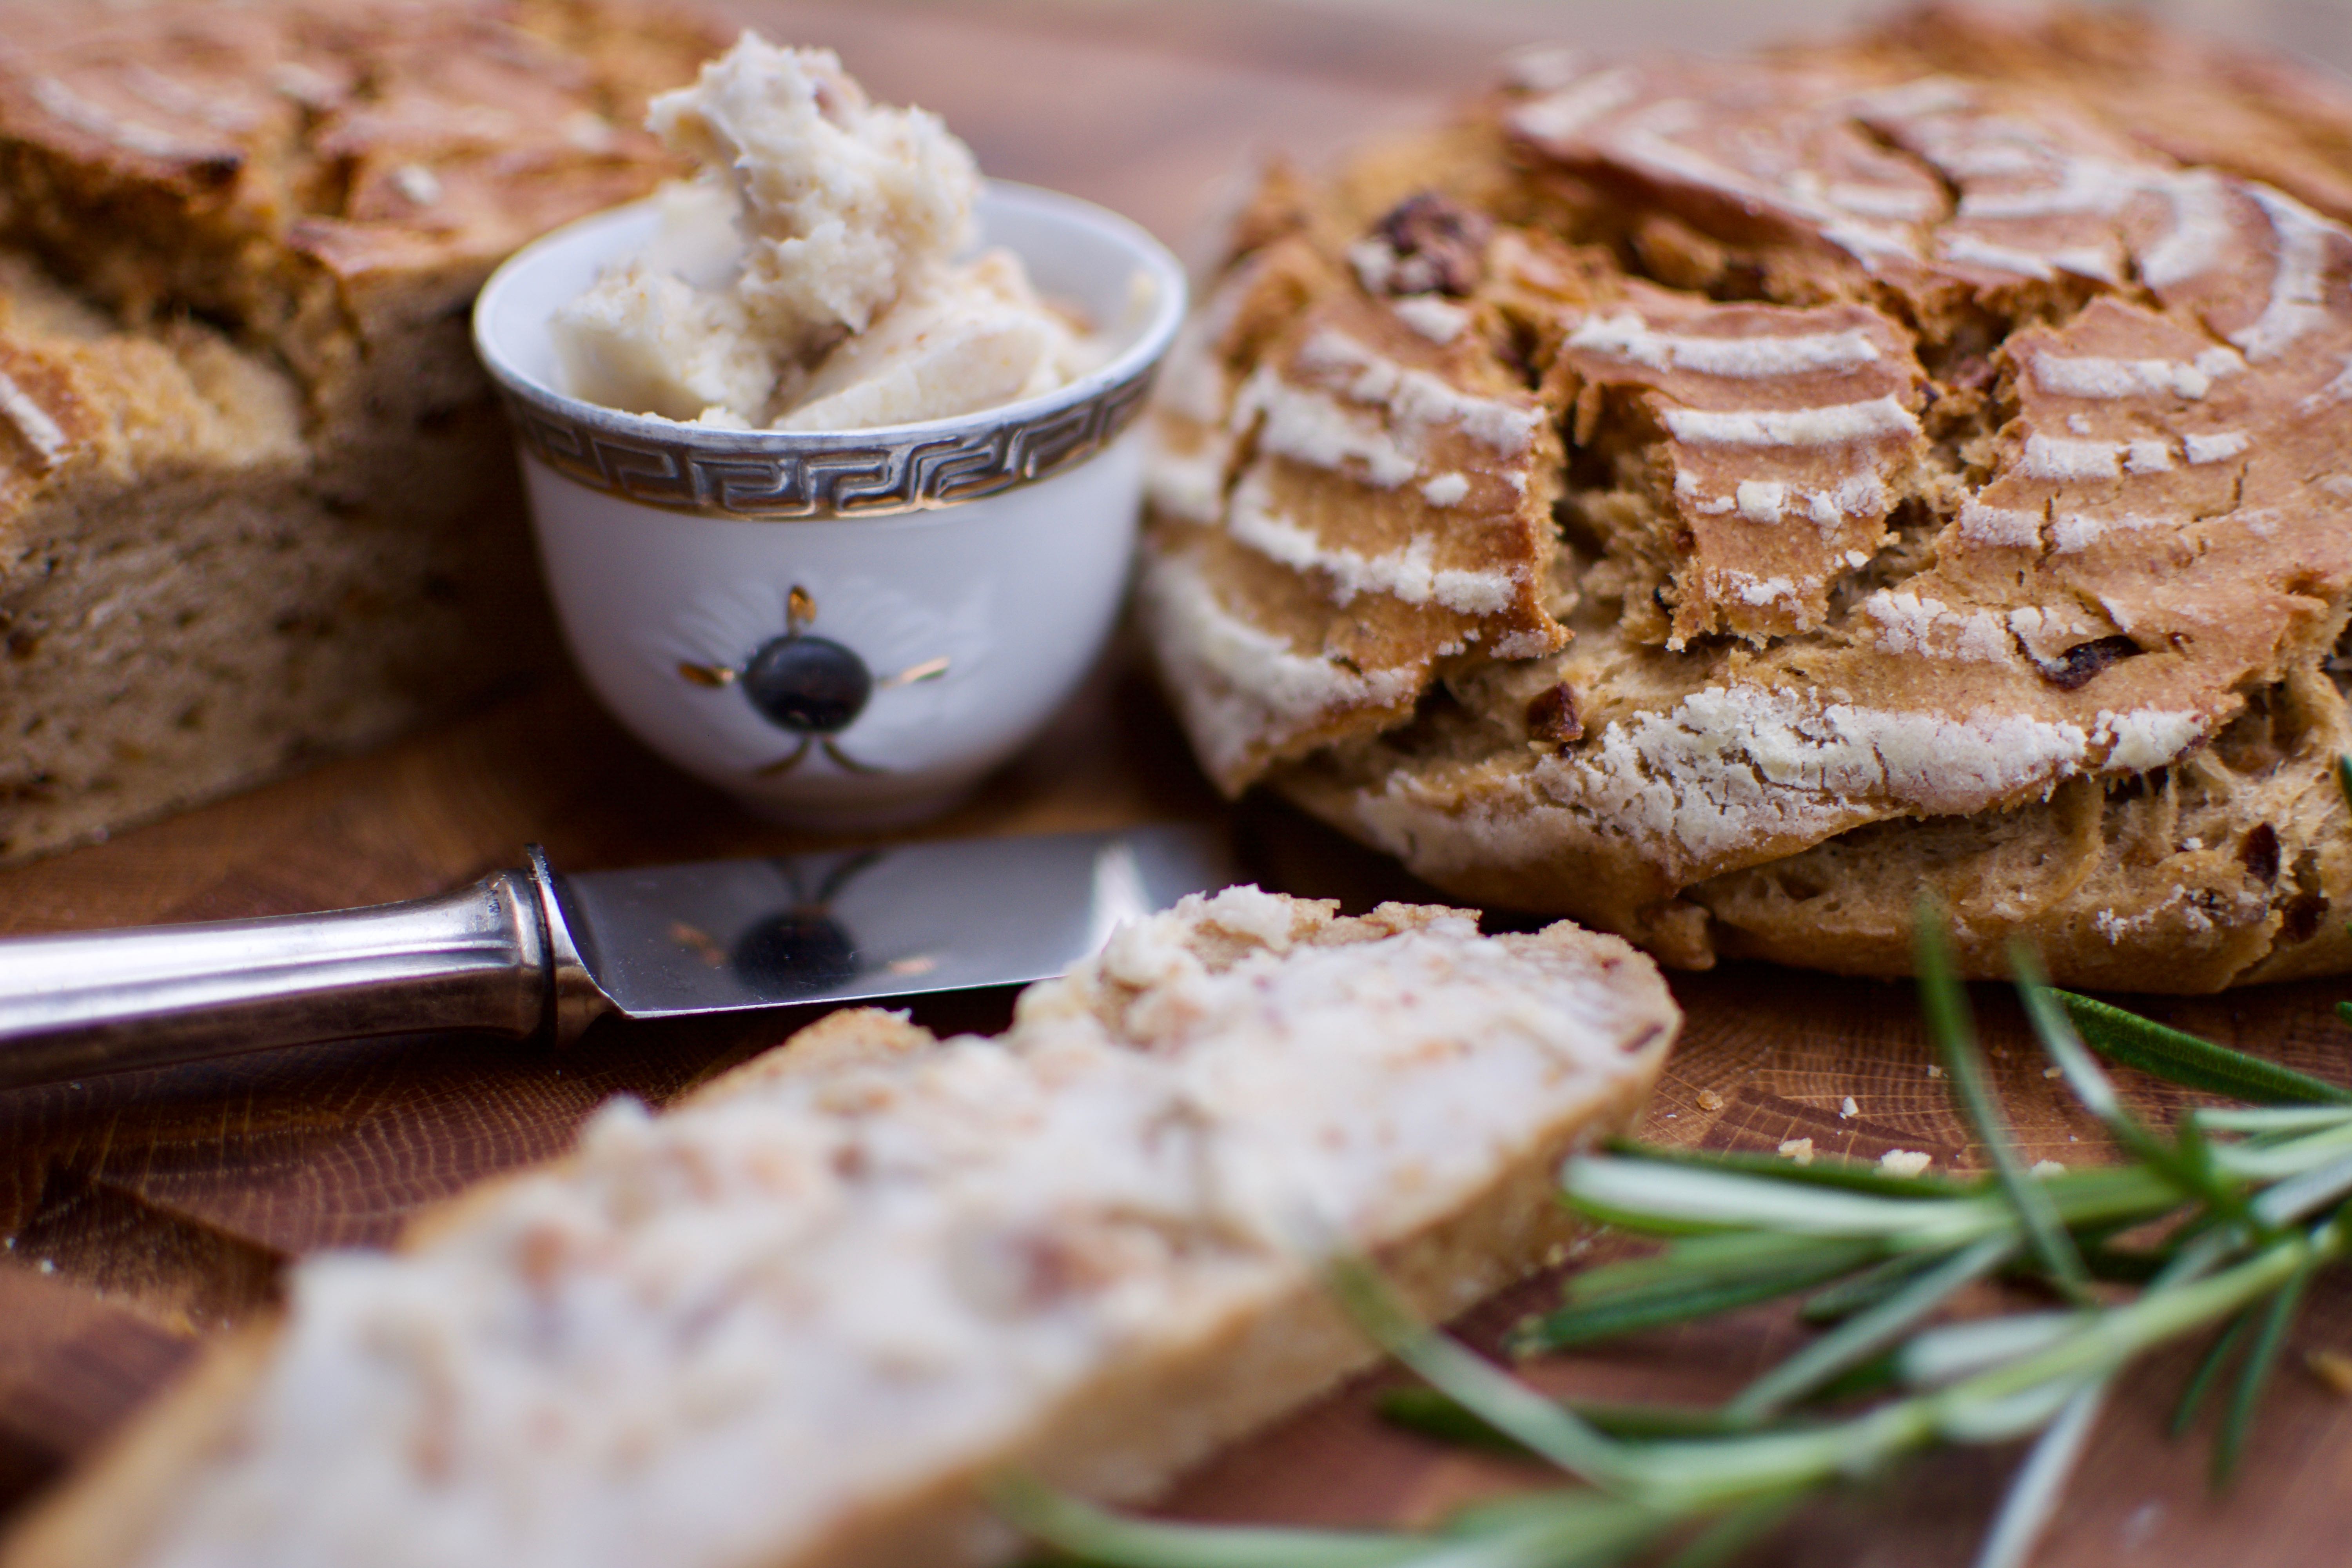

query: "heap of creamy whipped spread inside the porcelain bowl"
left=548, top=33, right=1108, bottom=430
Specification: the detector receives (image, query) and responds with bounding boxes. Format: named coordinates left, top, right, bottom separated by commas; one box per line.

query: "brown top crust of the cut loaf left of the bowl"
left=0, top=0, right=715, bottom=423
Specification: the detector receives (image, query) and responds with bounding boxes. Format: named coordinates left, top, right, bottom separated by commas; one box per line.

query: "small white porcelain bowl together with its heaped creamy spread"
left=473, top=35, right=1185, bottom=828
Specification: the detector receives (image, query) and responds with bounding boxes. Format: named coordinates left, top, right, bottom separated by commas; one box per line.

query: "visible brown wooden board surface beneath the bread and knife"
left=0, top=0, right=2352, bottom=1568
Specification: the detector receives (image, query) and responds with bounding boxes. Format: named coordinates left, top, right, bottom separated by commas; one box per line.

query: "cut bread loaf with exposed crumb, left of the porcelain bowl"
left=0, top=0, right=720, bottom=860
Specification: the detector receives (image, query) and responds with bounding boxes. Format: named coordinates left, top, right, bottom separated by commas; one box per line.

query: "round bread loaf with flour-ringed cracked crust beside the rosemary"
left=1143, top=9, right=2352, bottom=990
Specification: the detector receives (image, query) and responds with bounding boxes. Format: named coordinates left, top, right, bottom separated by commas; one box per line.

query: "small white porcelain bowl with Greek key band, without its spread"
left=473, top=181, right=1185, bottom=828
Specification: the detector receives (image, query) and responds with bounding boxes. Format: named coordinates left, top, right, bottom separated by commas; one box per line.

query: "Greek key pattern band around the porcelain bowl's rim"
left=499, top=365, right=1155, bottom=522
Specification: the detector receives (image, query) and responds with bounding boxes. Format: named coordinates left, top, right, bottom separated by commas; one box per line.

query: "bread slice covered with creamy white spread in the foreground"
left=0, top=889, right=1679, bottom=1568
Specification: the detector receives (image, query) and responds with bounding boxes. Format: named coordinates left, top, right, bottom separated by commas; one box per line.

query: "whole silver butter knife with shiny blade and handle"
left=0, top=825, right=1235, bottom=1089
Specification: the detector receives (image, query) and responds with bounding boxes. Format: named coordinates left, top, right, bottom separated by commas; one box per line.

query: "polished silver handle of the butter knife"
left=0, top=844, right=612, bottom=1089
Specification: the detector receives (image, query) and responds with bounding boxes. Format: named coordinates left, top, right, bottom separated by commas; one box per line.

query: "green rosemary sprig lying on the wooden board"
left=1000, top=912, right=2352, bottom=1568
